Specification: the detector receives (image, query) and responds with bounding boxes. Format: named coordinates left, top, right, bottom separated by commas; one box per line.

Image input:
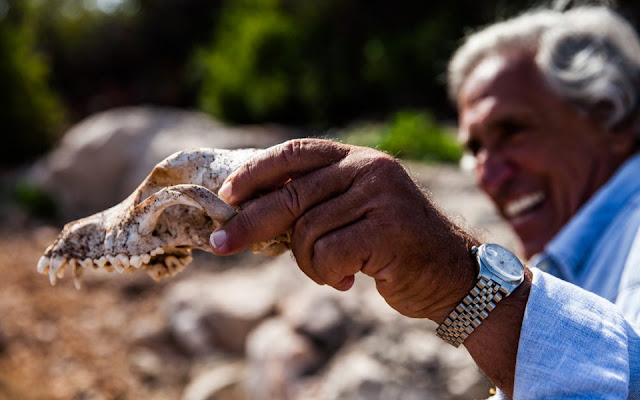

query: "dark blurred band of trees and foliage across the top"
left=0, top=0, right=640, bottom=171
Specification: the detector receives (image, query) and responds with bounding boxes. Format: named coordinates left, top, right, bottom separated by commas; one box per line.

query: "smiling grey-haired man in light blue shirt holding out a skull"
left=211, top=4, right=640, bottom=399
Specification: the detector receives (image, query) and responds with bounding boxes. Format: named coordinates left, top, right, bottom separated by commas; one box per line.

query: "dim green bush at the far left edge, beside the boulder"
left=0, top=0, right=65, bottom=165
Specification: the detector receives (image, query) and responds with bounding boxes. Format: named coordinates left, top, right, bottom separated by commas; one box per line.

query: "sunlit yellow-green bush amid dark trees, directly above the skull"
left=196, top=0, right=296, bottom=121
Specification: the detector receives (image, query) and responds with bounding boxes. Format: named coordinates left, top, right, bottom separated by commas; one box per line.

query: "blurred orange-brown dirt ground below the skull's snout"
left=0, top=223, right=184, bottom=400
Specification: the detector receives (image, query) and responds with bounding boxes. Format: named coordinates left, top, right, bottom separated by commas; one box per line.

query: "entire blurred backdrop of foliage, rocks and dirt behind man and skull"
left=0, top=0, right=640, bottom=400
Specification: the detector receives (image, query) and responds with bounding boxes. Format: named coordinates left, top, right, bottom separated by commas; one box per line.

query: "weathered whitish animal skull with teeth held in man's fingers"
left=37, top=148, right=289, bottom=287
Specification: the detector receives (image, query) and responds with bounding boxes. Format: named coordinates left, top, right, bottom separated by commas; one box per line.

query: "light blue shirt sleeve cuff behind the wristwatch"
left=514, top=268, right=640, bottom=400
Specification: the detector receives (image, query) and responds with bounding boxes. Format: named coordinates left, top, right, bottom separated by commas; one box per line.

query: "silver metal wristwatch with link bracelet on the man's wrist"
left=436, top=243, right=524, bottom=347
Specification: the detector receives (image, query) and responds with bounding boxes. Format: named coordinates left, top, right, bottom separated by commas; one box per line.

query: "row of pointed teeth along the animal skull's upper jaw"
left=38, top=247, right=192, bottom=289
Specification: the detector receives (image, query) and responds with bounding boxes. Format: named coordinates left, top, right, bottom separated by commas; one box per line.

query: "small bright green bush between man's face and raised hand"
left=343, top=110, right=462, bottom=162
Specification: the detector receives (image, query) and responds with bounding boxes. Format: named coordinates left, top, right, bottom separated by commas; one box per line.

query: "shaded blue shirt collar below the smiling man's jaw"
left=545, top=153, right=640, bottom=282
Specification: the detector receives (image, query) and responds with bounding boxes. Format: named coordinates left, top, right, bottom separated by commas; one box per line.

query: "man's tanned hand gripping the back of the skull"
left=212, top=139, right=477, bottom=322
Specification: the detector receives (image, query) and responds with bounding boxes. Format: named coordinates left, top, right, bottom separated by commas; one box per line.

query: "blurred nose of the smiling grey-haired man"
left=476, top=150, right=514, bottom=195
